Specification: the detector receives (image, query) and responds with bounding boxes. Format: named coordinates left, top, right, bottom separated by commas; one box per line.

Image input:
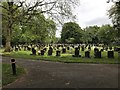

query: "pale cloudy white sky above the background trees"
left=56, top=0, right=113, bottom=37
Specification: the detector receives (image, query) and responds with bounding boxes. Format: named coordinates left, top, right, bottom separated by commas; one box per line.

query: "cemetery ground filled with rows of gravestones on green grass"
left=3, top=44, right=120, bottom=64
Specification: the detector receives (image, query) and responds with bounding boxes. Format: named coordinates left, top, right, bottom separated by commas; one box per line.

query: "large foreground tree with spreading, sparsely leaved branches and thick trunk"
left=0, top=0, right=77, bottom=52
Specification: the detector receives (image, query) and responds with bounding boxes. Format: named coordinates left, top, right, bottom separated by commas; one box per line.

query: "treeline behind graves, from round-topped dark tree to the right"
left=60, top=22, right=118, bottom=45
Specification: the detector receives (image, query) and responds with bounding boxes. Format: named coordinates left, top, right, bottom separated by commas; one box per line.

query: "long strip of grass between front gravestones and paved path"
left=3, top=47, right=120, bottom=64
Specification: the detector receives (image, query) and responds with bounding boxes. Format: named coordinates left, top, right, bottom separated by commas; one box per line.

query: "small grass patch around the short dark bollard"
left=2, top=63, right=25, bottom=86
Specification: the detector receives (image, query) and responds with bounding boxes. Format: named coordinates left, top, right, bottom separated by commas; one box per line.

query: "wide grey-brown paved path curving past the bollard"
left=2, top=57, right=118, bottom=88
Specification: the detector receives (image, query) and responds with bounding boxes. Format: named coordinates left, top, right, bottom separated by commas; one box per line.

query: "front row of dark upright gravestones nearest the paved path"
left=31, top=47, right=114, bottom=58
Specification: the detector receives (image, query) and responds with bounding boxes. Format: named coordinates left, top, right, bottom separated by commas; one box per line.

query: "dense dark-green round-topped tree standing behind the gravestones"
left=61, top=22, right=82, bottom=43
